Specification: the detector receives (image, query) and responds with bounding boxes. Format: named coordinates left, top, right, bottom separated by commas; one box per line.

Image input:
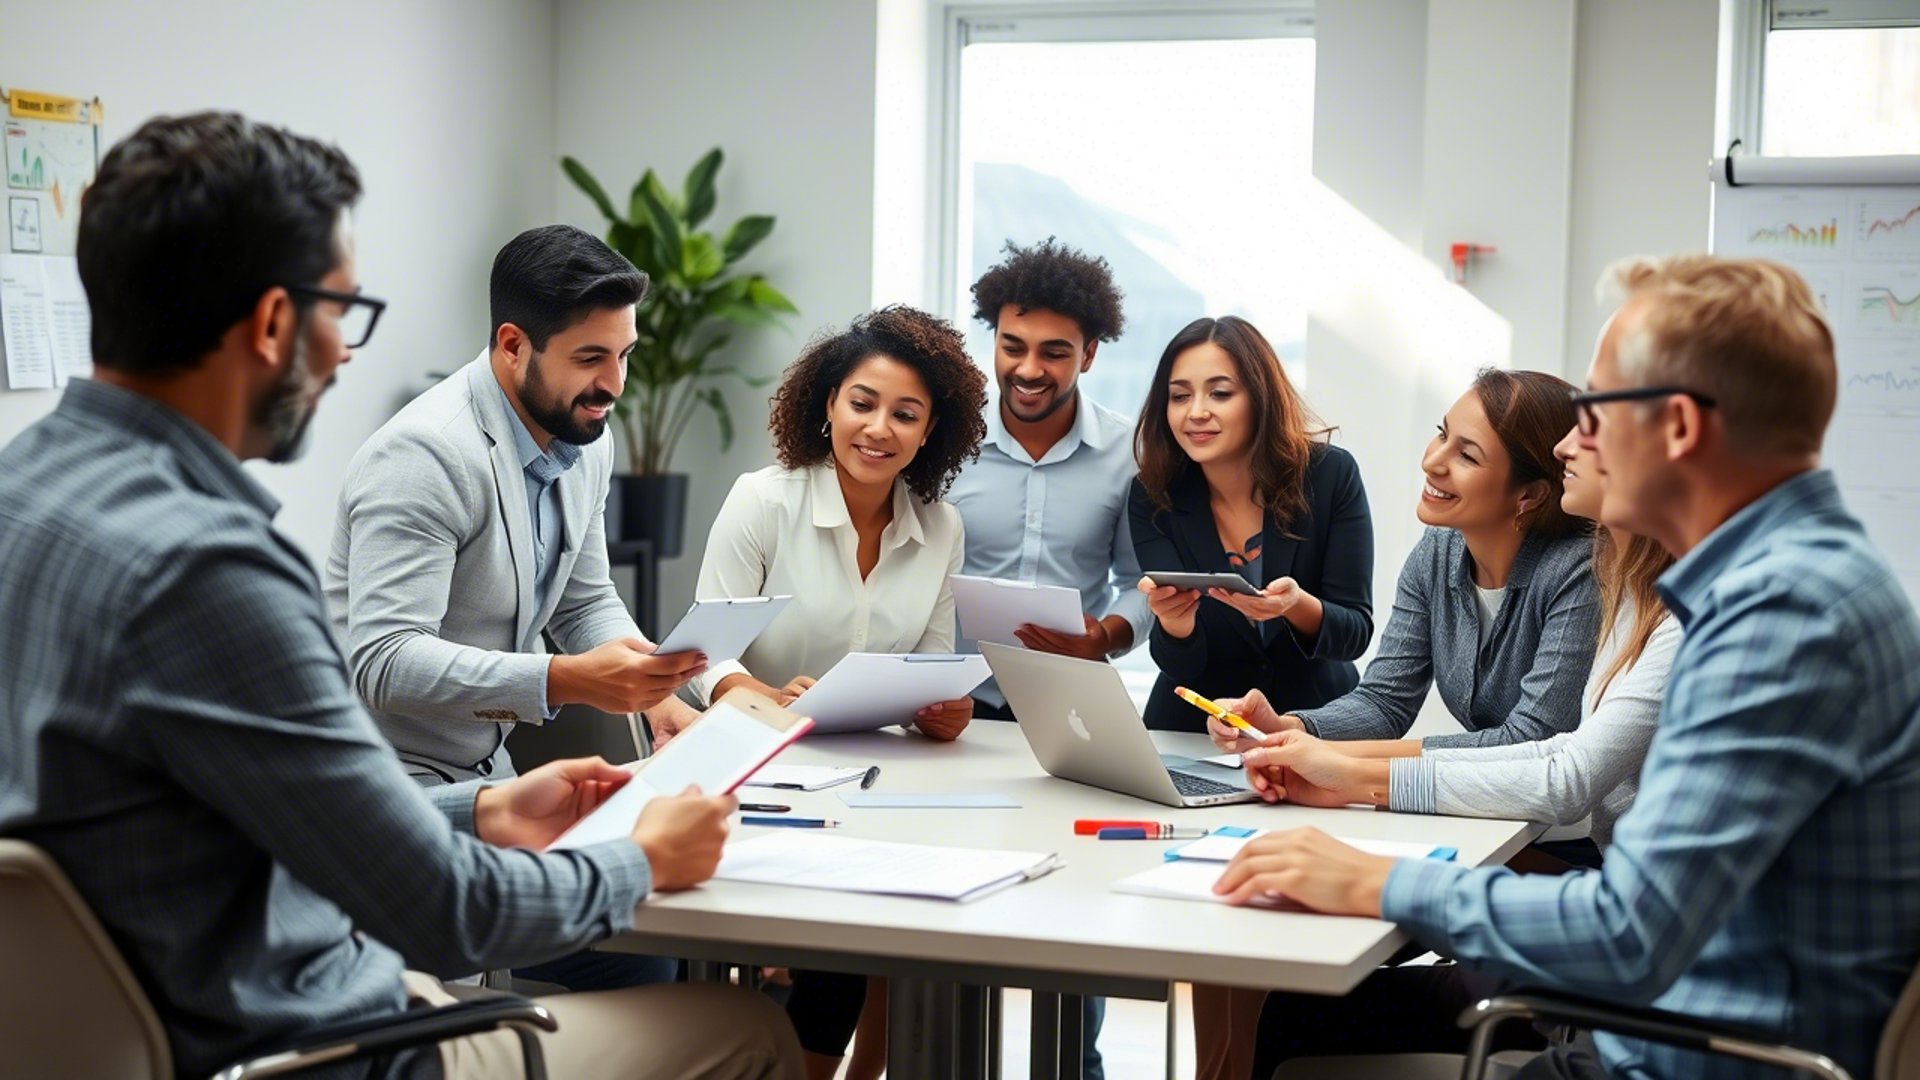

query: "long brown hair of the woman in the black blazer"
left=1133, top=315, right=1332, bottom=536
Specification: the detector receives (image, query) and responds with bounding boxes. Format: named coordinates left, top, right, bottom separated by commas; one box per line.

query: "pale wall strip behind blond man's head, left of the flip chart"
left=1565, top=0, right=1720, bottom=374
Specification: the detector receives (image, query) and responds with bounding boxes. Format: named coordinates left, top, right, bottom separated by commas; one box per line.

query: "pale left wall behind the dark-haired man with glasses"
left=0, top=0, right=555, bottom=559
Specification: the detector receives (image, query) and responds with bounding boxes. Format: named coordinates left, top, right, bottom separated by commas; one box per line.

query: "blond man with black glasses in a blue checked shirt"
left=1215, top=256, right=1920, bottom=1080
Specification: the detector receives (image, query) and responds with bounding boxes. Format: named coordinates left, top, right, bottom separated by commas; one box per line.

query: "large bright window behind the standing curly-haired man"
left=933, top=4, right=1313, bottom=700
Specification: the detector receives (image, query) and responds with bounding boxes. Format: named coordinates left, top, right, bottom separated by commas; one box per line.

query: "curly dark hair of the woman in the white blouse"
left=766, top=304, right=987, bottom=503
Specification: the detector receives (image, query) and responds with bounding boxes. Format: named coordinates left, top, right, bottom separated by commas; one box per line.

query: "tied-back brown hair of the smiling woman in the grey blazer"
left=1473, top=367, right=1592, bottom=538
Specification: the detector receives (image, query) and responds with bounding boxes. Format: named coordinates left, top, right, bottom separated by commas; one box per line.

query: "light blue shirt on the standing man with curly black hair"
left=947, top=394, right=1152, bottom=705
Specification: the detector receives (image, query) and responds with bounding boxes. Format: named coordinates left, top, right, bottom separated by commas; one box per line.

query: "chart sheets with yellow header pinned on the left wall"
left=0, top=86, right=102, bottom=390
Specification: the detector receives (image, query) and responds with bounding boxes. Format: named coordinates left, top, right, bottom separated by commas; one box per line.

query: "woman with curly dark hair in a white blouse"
left=693, top=307, right=987, bottom=740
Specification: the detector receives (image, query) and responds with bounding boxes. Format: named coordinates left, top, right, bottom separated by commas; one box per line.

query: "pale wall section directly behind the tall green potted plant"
left=549, top=0, right=876, bottom=623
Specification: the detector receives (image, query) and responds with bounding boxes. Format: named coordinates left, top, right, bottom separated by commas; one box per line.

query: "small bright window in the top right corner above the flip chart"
left=1734, top=0, right=1920, bottom=158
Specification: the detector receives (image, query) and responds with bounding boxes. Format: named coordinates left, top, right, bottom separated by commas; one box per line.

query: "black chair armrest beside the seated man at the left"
left=213, top=995, right=561, bottom=1080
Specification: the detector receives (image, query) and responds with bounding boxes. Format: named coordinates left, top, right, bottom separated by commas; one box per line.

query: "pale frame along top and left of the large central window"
left=925, top=0, right=1313, bottom=323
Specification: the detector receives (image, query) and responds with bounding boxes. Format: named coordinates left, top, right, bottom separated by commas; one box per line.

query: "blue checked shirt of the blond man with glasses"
left=1380, top=471, right=1920, bottom=1080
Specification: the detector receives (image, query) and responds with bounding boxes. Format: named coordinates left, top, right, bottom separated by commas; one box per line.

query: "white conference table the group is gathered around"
left=599, top=721, right=1540, bottom=1078
